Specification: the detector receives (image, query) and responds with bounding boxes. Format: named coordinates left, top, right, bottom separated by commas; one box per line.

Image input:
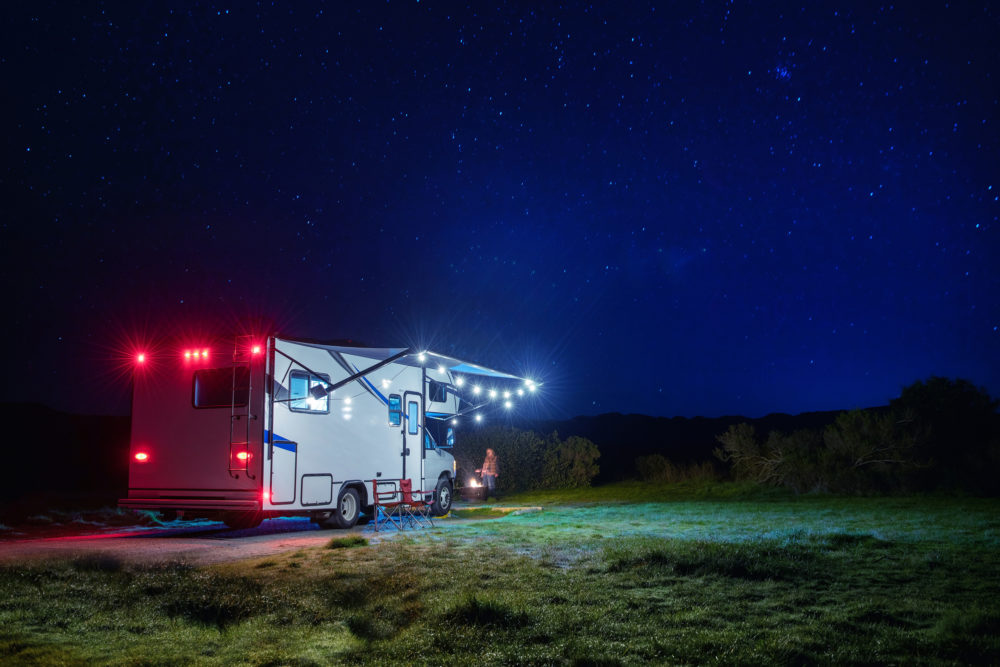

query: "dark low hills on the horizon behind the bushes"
left=524, top=408, right=878, bottom=483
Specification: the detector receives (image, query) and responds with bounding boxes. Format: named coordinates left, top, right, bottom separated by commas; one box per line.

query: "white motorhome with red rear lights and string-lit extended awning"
left=119, top=335, right=535, bottom=528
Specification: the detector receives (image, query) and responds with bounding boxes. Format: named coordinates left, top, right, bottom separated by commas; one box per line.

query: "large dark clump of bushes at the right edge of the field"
left=715, top=378, right=1000, bottom=494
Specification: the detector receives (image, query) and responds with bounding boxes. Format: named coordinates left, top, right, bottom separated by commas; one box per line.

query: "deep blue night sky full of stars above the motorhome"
left=0, top=0, right=1000, bottom=417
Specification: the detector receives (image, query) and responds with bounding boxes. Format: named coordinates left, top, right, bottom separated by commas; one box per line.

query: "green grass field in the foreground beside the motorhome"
left=0, top=484, right=1000, bottom=665
